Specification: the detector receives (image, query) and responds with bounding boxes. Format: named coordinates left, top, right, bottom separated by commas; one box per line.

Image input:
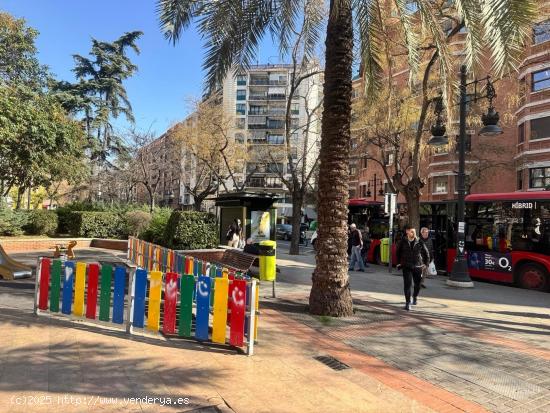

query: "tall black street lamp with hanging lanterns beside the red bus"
left=428, top=65, right=502, bottom=287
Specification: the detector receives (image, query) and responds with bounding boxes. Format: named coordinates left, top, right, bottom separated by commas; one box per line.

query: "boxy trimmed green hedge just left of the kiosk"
left=163, top=211, right=218, bottom=250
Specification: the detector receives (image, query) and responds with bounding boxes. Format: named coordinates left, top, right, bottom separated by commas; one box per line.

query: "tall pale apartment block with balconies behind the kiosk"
left=222, top=64, right=323, bottom=220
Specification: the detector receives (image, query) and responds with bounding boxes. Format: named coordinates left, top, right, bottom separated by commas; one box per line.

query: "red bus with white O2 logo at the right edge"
left=447, top=191, right=550, bottom=291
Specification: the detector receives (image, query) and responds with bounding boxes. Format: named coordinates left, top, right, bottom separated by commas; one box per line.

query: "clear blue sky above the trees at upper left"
left=0, top=0, right=279, bottom=134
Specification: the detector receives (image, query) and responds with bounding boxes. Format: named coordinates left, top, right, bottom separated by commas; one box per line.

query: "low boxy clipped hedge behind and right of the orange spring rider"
left=66, top=211, right=124, bottom=238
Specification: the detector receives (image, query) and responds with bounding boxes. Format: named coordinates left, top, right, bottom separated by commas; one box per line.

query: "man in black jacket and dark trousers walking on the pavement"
left=396, top=225, right=430, bottom=311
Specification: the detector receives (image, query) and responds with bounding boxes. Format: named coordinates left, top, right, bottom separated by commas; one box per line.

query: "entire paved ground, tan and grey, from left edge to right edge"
left=0, top=251, right=550, bottom=413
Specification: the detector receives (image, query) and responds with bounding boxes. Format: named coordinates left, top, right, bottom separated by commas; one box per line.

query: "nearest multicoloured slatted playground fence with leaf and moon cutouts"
left=34, top=254, right=259, bottom=355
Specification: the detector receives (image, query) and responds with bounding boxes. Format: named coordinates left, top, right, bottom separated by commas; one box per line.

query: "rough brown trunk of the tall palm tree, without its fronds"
left=309, top=0, right=353, bottom=317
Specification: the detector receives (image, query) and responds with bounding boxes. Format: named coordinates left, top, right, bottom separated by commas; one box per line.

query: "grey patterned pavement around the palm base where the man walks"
left=272, top=248, right=550, bottom=412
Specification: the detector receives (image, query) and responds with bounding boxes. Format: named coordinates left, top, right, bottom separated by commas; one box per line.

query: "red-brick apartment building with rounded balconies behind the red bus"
left=349, top=8, right=550, bottom=202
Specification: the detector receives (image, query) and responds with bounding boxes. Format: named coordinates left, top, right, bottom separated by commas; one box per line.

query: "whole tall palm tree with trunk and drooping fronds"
left=157, top=0, right=535, bottom=316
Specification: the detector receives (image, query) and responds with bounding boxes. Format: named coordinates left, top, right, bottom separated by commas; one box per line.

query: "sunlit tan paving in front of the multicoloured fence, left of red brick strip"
left=0, top=248, right=433, bottom=413
